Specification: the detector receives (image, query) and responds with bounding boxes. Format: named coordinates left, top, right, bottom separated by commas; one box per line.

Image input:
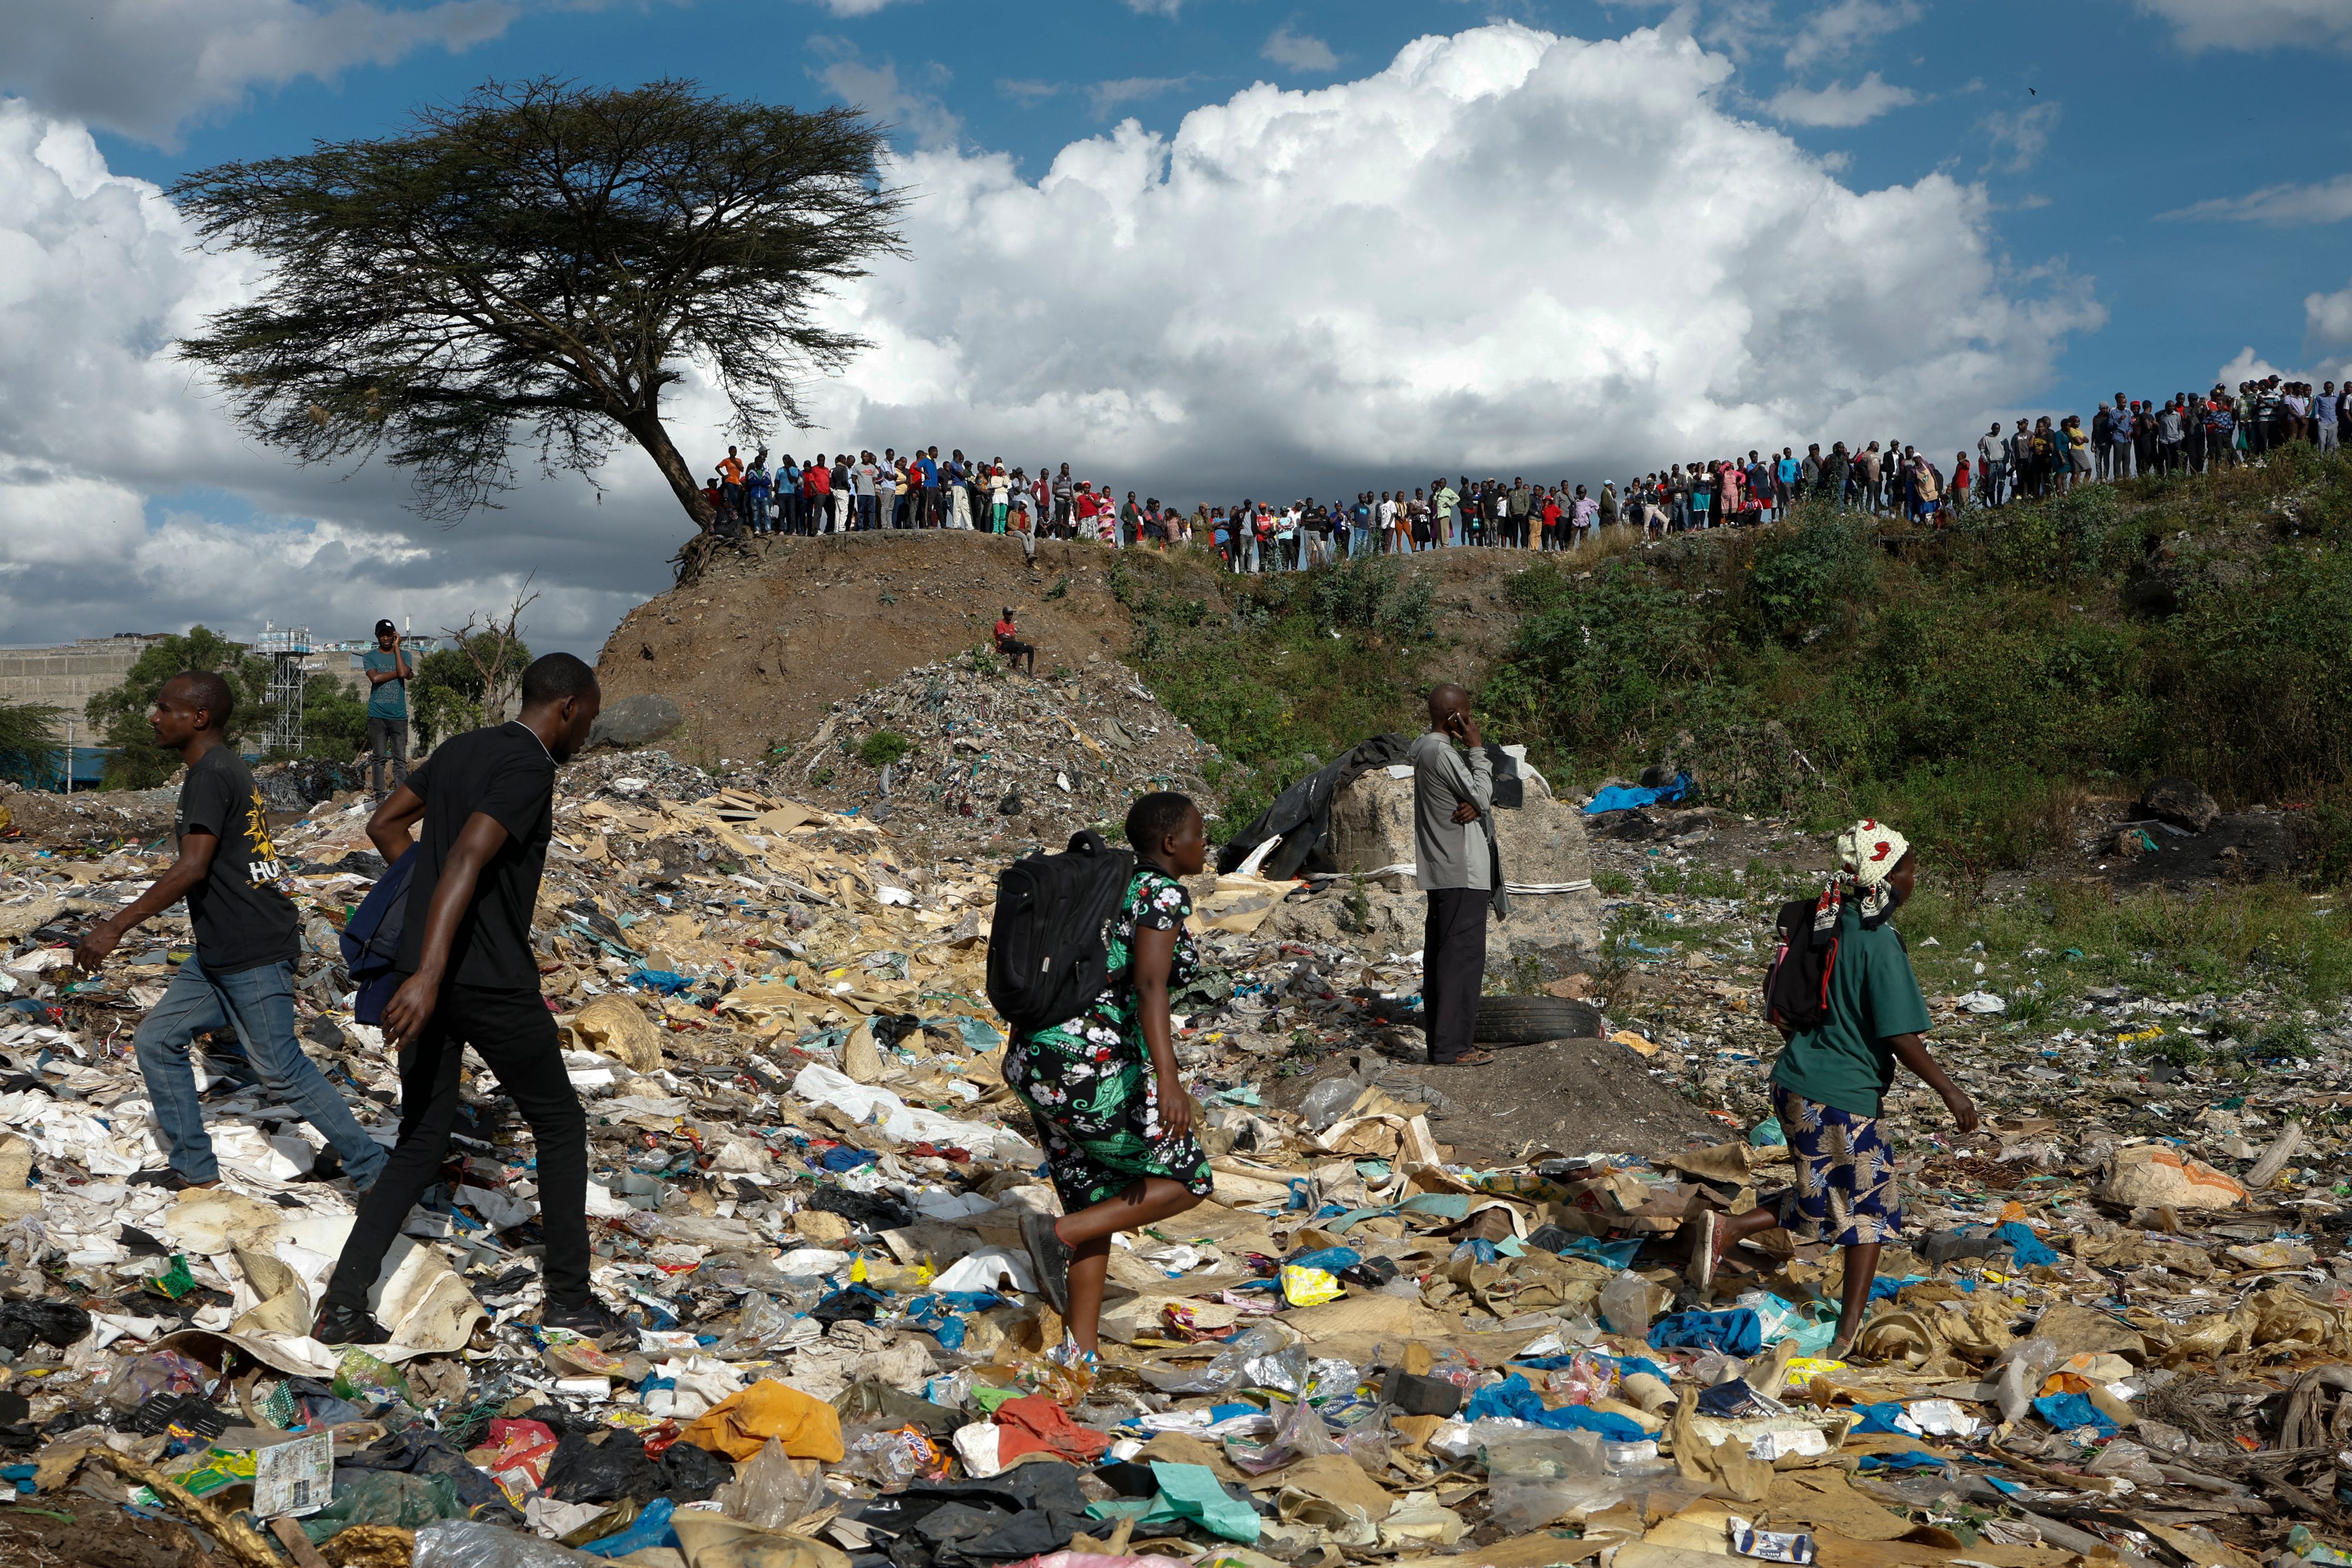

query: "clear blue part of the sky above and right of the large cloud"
left=83, top=0, right=2352, bottom=416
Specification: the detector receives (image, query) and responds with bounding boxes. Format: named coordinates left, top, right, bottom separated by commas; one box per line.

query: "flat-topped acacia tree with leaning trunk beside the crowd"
left=169, top=80, right=906, bottom=529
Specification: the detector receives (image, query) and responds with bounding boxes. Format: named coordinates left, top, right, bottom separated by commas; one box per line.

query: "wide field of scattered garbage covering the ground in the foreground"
left=0, top=752, right=2352, bottom=1568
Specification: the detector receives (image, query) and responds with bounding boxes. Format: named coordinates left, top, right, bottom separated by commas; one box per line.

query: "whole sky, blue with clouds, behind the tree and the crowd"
left=0, top=0, right=2352, bottom=651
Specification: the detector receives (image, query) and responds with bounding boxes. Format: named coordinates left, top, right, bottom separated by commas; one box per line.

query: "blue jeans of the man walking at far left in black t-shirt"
left=136, top=952, right=386, bottom=1189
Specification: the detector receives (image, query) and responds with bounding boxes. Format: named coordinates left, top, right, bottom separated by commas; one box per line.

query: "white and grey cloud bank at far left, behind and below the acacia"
left=0, top=99, right=663, bottom=654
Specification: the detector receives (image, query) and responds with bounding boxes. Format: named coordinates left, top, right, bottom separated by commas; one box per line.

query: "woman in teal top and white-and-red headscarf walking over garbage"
left=1689, top=820, right=1976, bottom=1361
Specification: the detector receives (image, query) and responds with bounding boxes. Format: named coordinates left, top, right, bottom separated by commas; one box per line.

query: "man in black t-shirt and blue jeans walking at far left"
left=73, top=670, right=383, bottom=1189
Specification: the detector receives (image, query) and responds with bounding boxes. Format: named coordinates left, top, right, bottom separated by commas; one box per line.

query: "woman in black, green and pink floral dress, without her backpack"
left=1004, top=794, right=1211, bottom=1356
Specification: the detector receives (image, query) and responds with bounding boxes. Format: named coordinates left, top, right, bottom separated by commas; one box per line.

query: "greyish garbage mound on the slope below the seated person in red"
left=774, top=654, right=1218, bottom=851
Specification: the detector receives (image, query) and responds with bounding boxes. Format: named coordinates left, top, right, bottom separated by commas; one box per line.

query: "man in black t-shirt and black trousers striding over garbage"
left=310, top=654, right=619, bottom=1345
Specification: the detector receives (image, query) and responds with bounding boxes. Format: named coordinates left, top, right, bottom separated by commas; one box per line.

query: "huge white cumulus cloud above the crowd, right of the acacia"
left=804, top=24, right=2103, bottom=501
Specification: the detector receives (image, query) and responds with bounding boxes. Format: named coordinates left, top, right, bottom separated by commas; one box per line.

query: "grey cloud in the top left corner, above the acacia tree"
left=0, top=0, right=520, bottom=143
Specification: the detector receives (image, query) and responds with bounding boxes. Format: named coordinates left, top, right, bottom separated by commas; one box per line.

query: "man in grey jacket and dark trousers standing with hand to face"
left=1409, top=687, right=1494, bottom=1065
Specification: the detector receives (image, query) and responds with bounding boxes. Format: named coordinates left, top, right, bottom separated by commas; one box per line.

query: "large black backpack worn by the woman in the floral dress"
left=988, top=827, right=1136, bottom=1034
